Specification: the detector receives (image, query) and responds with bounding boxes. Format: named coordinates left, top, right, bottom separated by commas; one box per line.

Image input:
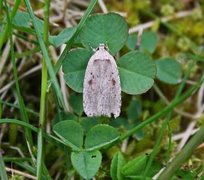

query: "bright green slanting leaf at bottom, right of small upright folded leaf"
left=122, top=155, right=147, bottom=176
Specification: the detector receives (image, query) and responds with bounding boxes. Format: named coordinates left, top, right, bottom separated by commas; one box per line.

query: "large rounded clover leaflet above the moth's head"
left=78, top=13, right=128, bottom=55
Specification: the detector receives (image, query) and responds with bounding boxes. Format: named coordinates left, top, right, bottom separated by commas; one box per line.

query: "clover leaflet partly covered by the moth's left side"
left=62, top=49, right=92, bottom=93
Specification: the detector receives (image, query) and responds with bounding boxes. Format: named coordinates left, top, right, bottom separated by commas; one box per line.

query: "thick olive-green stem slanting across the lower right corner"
left=158, top=126, right=204, bottom=180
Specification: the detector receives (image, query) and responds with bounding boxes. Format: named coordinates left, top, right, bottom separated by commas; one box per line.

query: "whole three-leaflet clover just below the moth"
left=53, top=120, right=119, bottom=179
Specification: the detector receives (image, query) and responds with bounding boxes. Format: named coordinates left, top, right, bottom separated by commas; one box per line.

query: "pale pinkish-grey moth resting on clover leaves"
left=83, top=44, right=121, bottom=118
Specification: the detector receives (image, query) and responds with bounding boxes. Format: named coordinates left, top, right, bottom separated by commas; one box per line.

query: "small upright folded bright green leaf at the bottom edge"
left=110, top=152, right=125, bottom=180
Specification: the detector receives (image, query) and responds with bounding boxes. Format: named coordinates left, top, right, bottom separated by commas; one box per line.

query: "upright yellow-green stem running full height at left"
left=37, top=0, right=50, bottom=177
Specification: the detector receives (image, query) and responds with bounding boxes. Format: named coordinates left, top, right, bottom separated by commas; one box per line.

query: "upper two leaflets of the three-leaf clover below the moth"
left=53, top=120, right=119, bottom=151
